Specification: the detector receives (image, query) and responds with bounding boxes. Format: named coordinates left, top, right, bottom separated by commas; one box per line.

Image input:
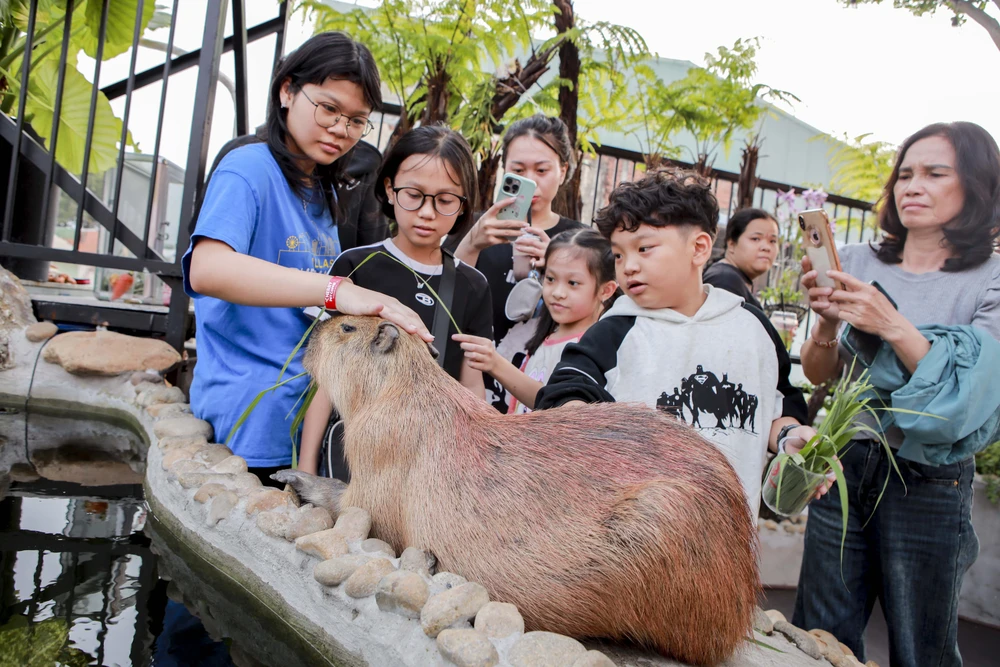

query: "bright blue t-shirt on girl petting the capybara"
left=183, top=144, right=340, bottom=467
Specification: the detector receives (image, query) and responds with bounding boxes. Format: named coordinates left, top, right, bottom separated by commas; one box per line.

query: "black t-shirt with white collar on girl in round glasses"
left=330, top=239, right=493, bottom=380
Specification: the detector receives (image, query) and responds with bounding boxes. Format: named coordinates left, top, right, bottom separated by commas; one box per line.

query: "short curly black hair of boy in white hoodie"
left=594, top=169, right=719, bottom=239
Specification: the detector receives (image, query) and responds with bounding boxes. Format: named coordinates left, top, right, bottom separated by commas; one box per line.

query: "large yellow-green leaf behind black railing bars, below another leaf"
left=25, top=58, right=122, bottom=174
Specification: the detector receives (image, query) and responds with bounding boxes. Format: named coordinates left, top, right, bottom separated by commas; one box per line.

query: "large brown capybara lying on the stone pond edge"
left=274, top=316, right=760, bottom=665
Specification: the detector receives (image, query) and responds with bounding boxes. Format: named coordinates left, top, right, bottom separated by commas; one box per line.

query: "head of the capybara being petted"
left=304, top=315, right=443, bottom=416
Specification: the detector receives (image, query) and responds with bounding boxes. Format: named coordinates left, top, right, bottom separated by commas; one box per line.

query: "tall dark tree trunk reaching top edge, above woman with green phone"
left=552, top=0, right=583, bottom=220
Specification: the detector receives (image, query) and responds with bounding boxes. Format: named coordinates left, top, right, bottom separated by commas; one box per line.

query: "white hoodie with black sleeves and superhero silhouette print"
left=535, top=285, right=805, bottom=517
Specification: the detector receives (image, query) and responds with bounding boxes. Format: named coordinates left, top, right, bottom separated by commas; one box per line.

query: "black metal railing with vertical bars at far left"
left=0, top=0, right=288, bottom=349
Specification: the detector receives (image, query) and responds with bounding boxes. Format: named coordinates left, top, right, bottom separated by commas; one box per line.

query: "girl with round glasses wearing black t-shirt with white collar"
left=299, top=125, right=493, bottom=475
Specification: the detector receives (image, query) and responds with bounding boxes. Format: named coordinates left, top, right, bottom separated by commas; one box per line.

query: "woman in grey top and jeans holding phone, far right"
left=793, top=122, right=1000, bottom=667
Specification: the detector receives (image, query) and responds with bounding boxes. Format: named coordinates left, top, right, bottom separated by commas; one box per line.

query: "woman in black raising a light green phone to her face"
left=455, top=115, right=584, bottom=413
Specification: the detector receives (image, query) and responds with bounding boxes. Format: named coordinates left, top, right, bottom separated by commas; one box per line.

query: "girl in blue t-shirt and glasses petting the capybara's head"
left=183, top=33, right=431, bottom=484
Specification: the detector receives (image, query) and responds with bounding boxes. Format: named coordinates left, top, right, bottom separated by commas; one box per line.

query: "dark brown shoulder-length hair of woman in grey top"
left=875, top=122, right=1000, bottom=271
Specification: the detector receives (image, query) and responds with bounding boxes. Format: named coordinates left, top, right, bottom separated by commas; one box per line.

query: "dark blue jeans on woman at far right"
left=792, top=440, right=979, bottom=667
